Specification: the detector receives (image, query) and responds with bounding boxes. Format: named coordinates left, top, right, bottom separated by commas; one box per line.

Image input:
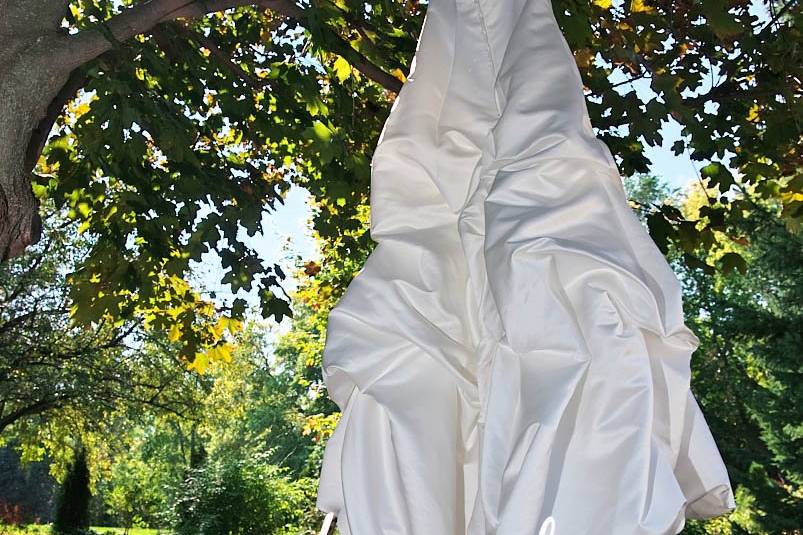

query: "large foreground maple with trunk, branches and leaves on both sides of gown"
left=0, top=0, right=803, bottom=359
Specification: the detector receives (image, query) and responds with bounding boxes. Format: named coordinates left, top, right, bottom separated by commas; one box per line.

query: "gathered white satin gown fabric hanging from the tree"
left=317, top=0, right=734, bottom=535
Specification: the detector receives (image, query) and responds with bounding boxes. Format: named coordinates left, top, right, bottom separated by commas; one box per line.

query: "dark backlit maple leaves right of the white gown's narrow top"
left=572, top=0, right=803, bottom=260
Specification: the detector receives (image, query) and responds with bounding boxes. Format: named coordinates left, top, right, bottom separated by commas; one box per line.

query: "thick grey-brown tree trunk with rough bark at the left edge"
left=0, top=0, right=70, bottom=261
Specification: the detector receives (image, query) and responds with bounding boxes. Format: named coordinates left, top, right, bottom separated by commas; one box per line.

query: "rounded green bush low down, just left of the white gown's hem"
left=171, top=454, right=315, bottom=535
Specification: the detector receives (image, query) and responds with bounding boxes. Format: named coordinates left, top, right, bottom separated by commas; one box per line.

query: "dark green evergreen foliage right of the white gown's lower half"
left=682, top=198, right=803, bottom=533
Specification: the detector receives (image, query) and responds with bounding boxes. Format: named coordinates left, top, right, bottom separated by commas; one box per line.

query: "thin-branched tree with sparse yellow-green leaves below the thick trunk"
left=0, top=216, right=210, bottom=486
